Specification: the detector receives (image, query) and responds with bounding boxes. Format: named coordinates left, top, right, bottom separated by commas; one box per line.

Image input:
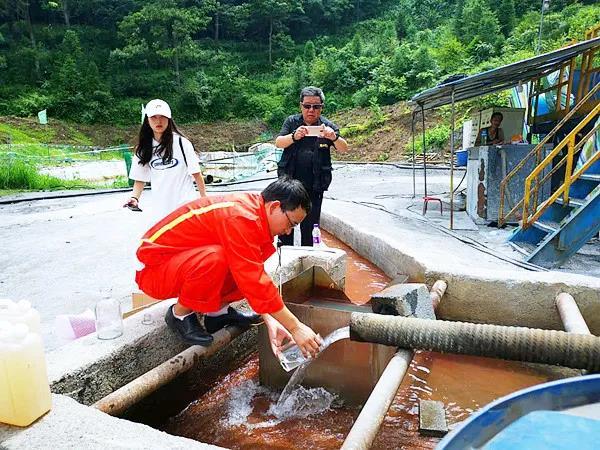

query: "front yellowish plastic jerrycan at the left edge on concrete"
left=0, top=308, right=52, bottom=427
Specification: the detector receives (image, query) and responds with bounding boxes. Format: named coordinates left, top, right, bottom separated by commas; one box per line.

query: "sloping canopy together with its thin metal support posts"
left=409, top=36, right=600, bottom=230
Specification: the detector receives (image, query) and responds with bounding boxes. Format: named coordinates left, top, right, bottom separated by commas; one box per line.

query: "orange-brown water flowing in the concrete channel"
left=162, top=233, right=549, bottom=450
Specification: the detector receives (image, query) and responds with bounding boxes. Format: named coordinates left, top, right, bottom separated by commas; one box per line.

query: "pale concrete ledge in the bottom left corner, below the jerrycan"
left=0, top=394, right=222, bottom=450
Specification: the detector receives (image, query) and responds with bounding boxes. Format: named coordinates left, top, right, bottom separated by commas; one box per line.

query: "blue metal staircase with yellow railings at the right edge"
left=498, top=25, right=600, bottom=268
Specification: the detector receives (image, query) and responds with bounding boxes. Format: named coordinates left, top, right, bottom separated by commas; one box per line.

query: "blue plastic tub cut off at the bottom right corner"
left=436, top=375, right=600, bottom=450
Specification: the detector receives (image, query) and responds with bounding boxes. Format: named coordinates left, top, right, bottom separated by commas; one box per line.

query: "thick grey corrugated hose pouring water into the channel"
left=350, top=313, right=600, bottom=372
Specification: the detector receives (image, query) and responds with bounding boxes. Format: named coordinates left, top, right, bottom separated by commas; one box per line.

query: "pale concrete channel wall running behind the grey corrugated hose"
left=322, top=212, right=600, bottom=335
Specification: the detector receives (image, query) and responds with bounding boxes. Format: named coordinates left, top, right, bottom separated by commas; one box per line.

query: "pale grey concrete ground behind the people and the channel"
left=0, top=164, right=600, bottom=349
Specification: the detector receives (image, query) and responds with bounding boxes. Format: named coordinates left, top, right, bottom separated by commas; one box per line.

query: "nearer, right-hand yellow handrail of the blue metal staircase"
left=522, top=103, right=600, bottom=229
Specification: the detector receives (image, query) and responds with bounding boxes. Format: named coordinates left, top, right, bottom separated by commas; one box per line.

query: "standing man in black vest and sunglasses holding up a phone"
left=275, top=86, right=348, bottom=246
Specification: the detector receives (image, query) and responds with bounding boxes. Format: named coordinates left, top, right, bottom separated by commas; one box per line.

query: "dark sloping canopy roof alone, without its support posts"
left=410, top=37, right=600, bottom=110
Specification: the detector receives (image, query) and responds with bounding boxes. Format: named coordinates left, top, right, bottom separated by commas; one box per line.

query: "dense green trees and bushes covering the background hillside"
left=0, top=0, right=600, bottom=127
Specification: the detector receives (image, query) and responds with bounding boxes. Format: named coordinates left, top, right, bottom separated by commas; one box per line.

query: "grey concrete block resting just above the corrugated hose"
left=371, top=283, right=435, bottom=319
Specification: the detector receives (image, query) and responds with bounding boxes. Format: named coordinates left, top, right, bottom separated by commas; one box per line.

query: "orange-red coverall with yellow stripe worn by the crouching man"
left=135, top=194, right=283, bottom=314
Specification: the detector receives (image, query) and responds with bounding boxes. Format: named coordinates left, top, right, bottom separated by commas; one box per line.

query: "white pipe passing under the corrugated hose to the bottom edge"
left=341, top=280, right=448, bottom=450
